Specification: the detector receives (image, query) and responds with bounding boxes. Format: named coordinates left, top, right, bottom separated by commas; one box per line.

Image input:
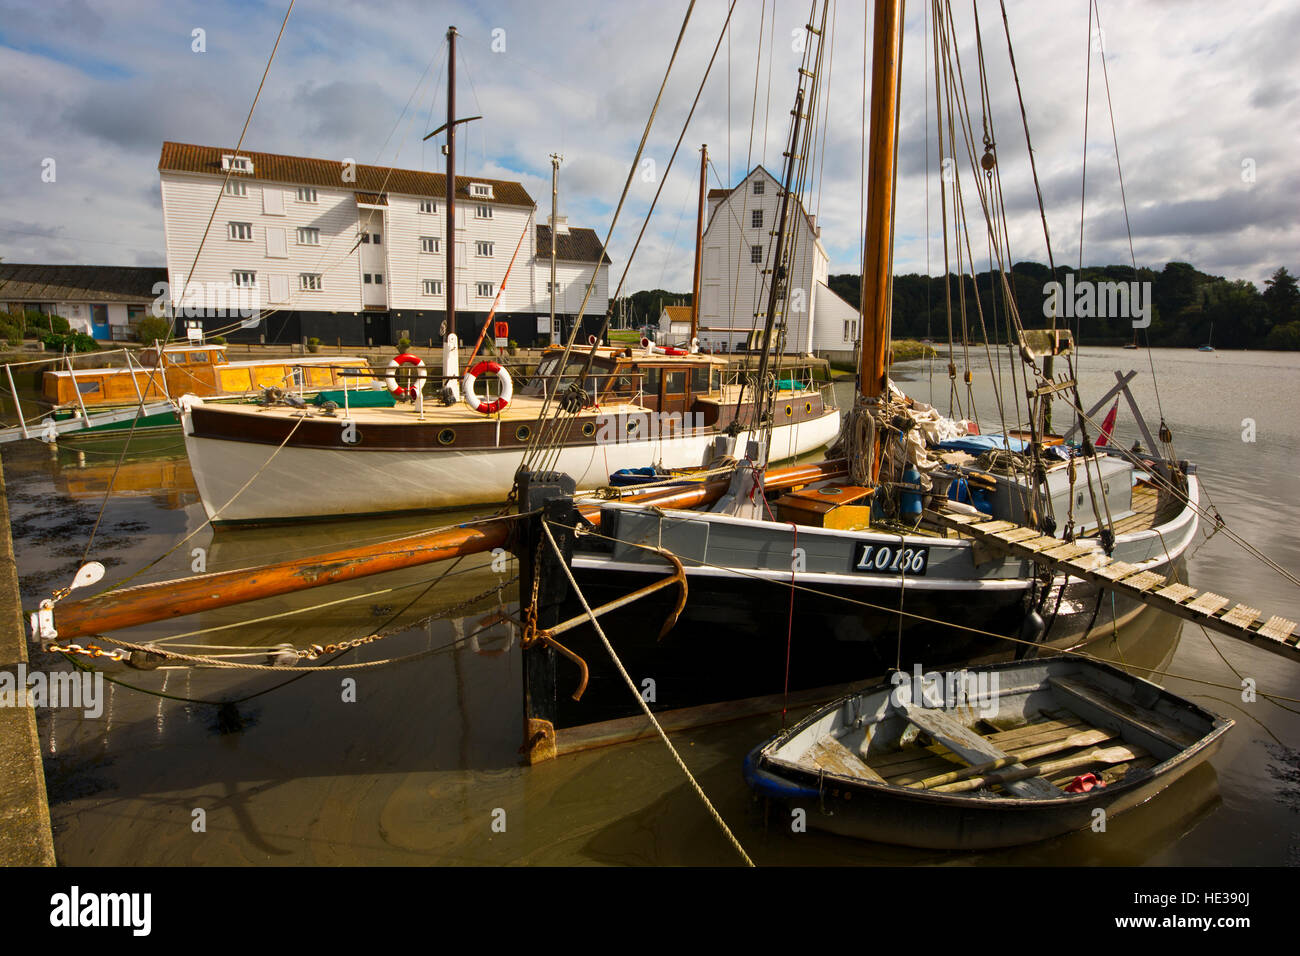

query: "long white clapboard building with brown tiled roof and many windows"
left=159, top=142, right=610, bottom=345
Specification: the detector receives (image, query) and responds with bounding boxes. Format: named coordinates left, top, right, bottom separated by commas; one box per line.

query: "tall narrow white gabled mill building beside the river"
left=699, top=166, right=858, bottom=352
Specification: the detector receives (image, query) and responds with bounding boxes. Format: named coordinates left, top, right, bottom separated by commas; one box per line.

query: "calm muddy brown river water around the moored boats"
left=4, top=349, right=1300, bottom=865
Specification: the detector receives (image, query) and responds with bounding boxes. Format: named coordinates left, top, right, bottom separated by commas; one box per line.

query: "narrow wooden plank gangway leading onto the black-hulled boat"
left=926, top=509, right=1300, bottom=661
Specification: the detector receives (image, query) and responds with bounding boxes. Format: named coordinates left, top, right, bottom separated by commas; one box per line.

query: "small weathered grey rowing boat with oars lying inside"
left=745, top=657, right=1232, bottom=849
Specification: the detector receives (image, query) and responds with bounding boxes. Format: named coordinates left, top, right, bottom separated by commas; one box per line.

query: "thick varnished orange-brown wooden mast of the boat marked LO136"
left=858, top=0, right=902, bottom=398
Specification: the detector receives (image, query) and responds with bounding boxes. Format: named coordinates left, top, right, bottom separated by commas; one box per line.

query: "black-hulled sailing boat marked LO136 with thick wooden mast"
left=506, top=0, right=1199, bottom=736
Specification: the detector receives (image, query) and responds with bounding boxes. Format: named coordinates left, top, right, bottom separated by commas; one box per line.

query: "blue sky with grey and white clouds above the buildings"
left=0, top=0, right=1300, bottom=291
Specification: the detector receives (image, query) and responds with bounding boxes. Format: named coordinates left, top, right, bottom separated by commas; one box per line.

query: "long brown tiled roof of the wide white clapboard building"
left=159, top=142, right=536, bottom=208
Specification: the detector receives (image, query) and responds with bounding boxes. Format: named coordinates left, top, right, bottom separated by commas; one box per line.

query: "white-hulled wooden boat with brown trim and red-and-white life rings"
left=181, top=27, right=840, bottom=524
